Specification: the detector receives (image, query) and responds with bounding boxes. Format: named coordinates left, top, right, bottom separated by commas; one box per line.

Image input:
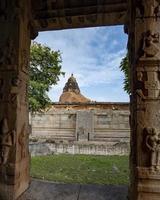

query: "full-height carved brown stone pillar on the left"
left=0, top=0, right=30, bottom=200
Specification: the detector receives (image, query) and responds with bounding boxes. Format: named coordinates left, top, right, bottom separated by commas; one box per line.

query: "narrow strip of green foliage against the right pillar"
left=120, top=53, right=131, bottom=94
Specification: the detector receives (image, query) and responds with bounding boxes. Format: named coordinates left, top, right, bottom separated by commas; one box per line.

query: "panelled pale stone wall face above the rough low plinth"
left=30, top=103, right=130, bottom=145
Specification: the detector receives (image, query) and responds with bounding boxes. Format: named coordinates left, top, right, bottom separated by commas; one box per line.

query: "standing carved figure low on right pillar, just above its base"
left=145, top=127, right=160, bottom=169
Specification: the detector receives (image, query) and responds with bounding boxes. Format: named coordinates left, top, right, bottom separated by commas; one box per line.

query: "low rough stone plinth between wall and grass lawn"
left=29, top=140, right=130, bottom=156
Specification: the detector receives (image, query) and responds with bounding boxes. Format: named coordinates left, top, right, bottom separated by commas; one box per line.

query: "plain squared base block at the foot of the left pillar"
left=0, top=156, right=30, bottom=200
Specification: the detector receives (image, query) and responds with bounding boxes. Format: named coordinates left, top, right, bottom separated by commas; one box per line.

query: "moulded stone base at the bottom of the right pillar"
left=137, top=167, right=160, bottom=200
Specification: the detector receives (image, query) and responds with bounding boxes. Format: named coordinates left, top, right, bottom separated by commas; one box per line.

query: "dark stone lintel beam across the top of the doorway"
left=32, top=0, right=127, bottom=31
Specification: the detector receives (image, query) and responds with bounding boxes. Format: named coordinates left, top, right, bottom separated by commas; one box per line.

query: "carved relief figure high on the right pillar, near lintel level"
left=142, top=30, right=160, bottom=58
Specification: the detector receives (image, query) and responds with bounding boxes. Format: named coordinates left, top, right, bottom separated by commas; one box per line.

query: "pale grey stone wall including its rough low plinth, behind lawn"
left=30, top=103, right=130, bottom=155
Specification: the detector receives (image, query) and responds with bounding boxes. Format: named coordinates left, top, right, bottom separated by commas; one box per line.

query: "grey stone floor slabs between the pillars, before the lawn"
left=19, top=180, right=127, bottom=200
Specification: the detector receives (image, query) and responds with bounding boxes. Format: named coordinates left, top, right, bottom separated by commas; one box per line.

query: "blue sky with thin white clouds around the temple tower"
left=36, top=26, right=129, bottom=102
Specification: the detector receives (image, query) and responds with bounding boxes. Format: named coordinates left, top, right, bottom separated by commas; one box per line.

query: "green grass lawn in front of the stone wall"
left=31, top=154, right=129, bottom=184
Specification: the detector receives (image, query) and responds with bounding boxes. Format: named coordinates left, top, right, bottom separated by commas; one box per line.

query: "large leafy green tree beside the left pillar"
left=28, top=42, right=64, bottom=113
